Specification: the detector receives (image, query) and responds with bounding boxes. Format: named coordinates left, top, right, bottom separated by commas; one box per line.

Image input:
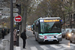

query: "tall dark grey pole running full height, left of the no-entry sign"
left=10, top=0, right=13, bottom=50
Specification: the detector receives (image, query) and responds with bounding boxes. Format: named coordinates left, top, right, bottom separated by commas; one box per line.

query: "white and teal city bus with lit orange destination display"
left=33, top=17, right=62, bottom=43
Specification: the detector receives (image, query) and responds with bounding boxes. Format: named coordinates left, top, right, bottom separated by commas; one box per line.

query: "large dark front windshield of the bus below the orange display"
left=40, top=22, right=61, bottom=33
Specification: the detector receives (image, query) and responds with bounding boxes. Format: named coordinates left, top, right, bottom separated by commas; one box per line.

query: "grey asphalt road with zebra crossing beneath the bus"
left=26, top=31, right=75, bottom=50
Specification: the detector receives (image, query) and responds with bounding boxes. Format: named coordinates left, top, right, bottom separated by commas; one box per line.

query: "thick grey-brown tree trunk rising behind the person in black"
left=17, top=0, right=31, bottom=31
